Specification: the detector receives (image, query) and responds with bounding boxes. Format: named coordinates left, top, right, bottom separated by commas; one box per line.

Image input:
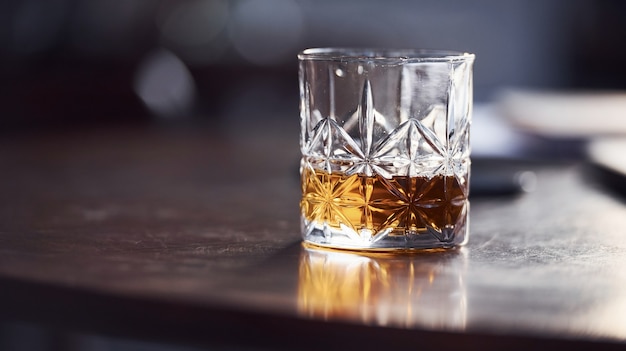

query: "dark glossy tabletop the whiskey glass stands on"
left=0, top=126, right=626, bottom=350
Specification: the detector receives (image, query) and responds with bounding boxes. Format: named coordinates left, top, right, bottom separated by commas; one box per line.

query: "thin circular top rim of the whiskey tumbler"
left=298, top=47, right=475, bottom=63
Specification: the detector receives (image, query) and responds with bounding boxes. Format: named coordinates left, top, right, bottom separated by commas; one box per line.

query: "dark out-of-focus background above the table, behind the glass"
left=0, top=0, right=626, bottom=133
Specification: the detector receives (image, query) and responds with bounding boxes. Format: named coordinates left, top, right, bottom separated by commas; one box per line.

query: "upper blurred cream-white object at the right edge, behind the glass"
left=498, top=90, right=626, bottom=138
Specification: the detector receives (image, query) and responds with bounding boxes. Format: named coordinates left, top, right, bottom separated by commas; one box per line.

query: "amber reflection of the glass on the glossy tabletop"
left=298, top=246, right=467, bottom=330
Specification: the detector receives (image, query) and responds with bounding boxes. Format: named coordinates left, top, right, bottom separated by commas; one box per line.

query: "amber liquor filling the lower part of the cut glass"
left=300, top=168, right=467, bottom=239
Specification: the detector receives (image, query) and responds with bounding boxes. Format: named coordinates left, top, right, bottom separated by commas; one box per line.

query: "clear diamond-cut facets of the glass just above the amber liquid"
left=303, top=69, right=471, bottom=179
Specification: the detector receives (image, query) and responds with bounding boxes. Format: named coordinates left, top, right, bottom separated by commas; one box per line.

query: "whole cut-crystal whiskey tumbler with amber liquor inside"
left=300, top=50, right=473, bottom=249
